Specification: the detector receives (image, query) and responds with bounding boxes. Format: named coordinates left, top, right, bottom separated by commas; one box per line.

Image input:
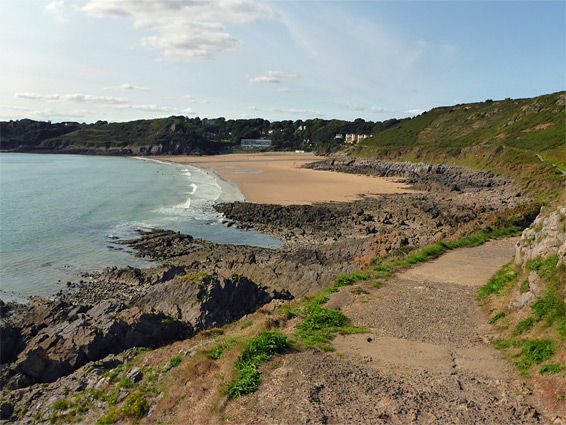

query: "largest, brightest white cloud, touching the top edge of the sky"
left=82, top=0, right=276, bottom=61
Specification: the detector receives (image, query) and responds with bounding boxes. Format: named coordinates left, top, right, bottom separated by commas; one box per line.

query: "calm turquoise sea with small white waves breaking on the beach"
left=0, top=153, right=282, bottom=302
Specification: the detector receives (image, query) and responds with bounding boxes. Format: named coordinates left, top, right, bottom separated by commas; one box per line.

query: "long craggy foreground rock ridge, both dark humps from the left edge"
left=1, top=270, right=280, bottom=388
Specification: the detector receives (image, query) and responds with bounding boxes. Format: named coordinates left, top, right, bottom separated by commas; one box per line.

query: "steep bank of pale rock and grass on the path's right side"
left=480, top=202, right=566, bottom=423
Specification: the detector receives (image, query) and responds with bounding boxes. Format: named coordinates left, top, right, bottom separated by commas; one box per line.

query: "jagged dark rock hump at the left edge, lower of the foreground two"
left=2, top=301, right=193, bottom=388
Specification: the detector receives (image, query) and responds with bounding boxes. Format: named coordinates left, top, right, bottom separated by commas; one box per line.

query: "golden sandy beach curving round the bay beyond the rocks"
left=155, top=153, right=416, bottom=205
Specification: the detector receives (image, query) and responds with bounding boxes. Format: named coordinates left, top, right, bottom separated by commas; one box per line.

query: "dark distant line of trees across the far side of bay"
left=0, top=116, right=408, bottom=155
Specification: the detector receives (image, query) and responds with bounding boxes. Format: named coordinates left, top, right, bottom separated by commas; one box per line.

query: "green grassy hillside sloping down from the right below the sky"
left=352, top=92, right=566, bottom=198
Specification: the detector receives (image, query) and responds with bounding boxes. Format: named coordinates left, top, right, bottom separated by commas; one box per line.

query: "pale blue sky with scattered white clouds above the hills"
left=0, top=0, right=566, bottom=123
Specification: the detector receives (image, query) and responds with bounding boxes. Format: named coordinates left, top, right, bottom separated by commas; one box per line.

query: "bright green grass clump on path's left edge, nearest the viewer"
left=224, top=331, right=291, bottom=399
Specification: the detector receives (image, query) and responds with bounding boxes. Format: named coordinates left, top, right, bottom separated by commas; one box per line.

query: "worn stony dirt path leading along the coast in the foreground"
left=227, top=239, right=544, bottom=424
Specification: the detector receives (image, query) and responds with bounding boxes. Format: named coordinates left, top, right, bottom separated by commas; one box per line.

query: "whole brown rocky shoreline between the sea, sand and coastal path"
left=0, top=158, right=527, bottom=420
